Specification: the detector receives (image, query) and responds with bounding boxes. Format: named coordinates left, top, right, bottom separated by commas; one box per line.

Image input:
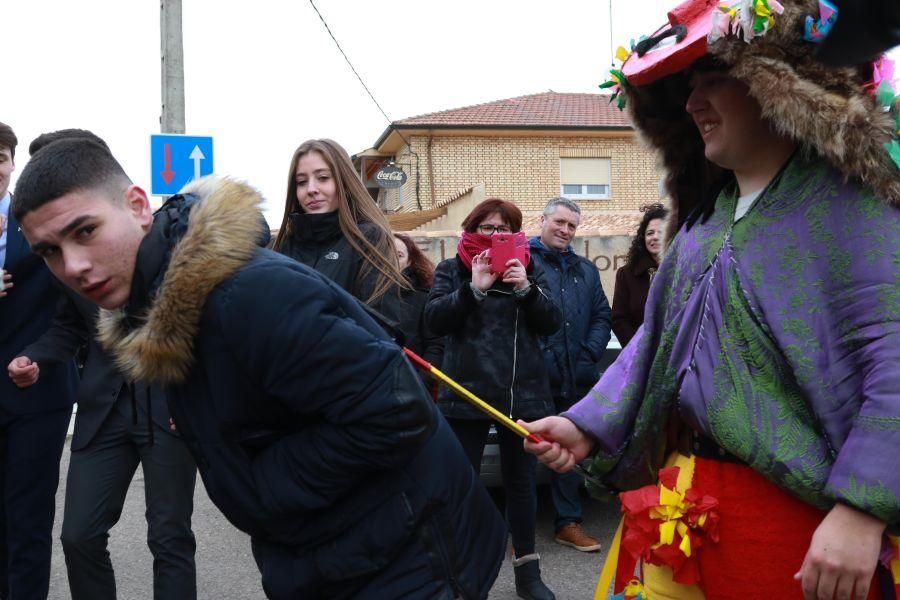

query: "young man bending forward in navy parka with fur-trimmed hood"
left=13, top=140, right=506, bottom=599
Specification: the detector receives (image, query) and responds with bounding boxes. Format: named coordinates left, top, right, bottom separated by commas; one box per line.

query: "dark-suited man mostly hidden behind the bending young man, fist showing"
left=8, top=129, right=197, bottom=600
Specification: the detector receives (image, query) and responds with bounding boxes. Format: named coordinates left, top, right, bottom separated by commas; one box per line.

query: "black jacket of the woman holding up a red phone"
left=425, top=257, right=561, bottom=420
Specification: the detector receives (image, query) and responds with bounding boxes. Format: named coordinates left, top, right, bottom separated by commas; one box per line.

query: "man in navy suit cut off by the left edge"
left=0, top=123, right=78, bottom=599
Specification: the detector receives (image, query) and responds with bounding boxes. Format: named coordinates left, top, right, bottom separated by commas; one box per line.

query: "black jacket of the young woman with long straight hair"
left=275, top=211, right=401, bottom=326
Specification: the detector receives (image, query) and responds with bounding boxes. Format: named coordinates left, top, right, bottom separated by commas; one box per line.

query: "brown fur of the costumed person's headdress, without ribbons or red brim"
left=623, top=0, right=900, bottom=237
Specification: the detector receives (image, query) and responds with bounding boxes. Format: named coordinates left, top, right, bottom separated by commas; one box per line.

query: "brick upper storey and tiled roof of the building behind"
left=355, top=92, right=660, bottom=216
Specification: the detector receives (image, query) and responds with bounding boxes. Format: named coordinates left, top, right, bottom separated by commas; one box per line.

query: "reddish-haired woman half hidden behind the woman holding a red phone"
left=394, top=233, right=444, bottom=399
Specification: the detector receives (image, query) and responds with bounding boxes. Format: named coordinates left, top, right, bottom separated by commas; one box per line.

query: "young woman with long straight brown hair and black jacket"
left=274, top=139, right=407, bottom=333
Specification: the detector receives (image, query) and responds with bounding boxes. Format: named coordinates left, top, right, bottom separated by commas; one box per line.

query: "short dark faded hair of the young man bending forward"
left=12, top=138, right=131, bottom=220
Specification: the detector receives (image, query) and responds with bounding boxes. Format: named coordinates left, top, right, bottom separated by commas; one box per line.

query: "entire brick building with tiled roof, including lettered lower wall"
left=354, top=92, right=661, bottom=299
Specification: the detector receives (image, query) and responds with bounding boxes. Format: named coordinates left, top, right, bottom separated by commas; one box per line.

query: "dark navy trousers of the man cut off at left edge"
left=0, top=406, right=72, bottom=600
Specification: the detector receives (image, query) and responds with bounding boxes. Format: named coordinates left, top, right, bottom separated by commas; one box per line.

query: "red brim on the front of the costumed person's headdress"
left=622, top=0, right=718, bottom=86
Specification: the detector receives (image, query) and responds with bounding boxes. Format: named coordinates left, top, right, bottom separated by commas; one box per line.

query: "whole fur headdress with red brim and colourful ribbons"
left=601, top=0, right=900, bottom=231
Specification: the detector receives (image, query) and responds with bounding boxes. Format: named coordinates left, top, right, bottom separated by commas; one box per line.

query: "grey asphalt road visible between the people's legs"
left=50, top=443, right=618, bottom=600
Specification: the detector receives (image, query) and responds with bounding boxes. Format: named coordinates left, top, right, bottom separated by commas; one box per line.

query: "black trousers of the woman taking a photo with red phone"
left=447, top=419, right=537, bottom=558
